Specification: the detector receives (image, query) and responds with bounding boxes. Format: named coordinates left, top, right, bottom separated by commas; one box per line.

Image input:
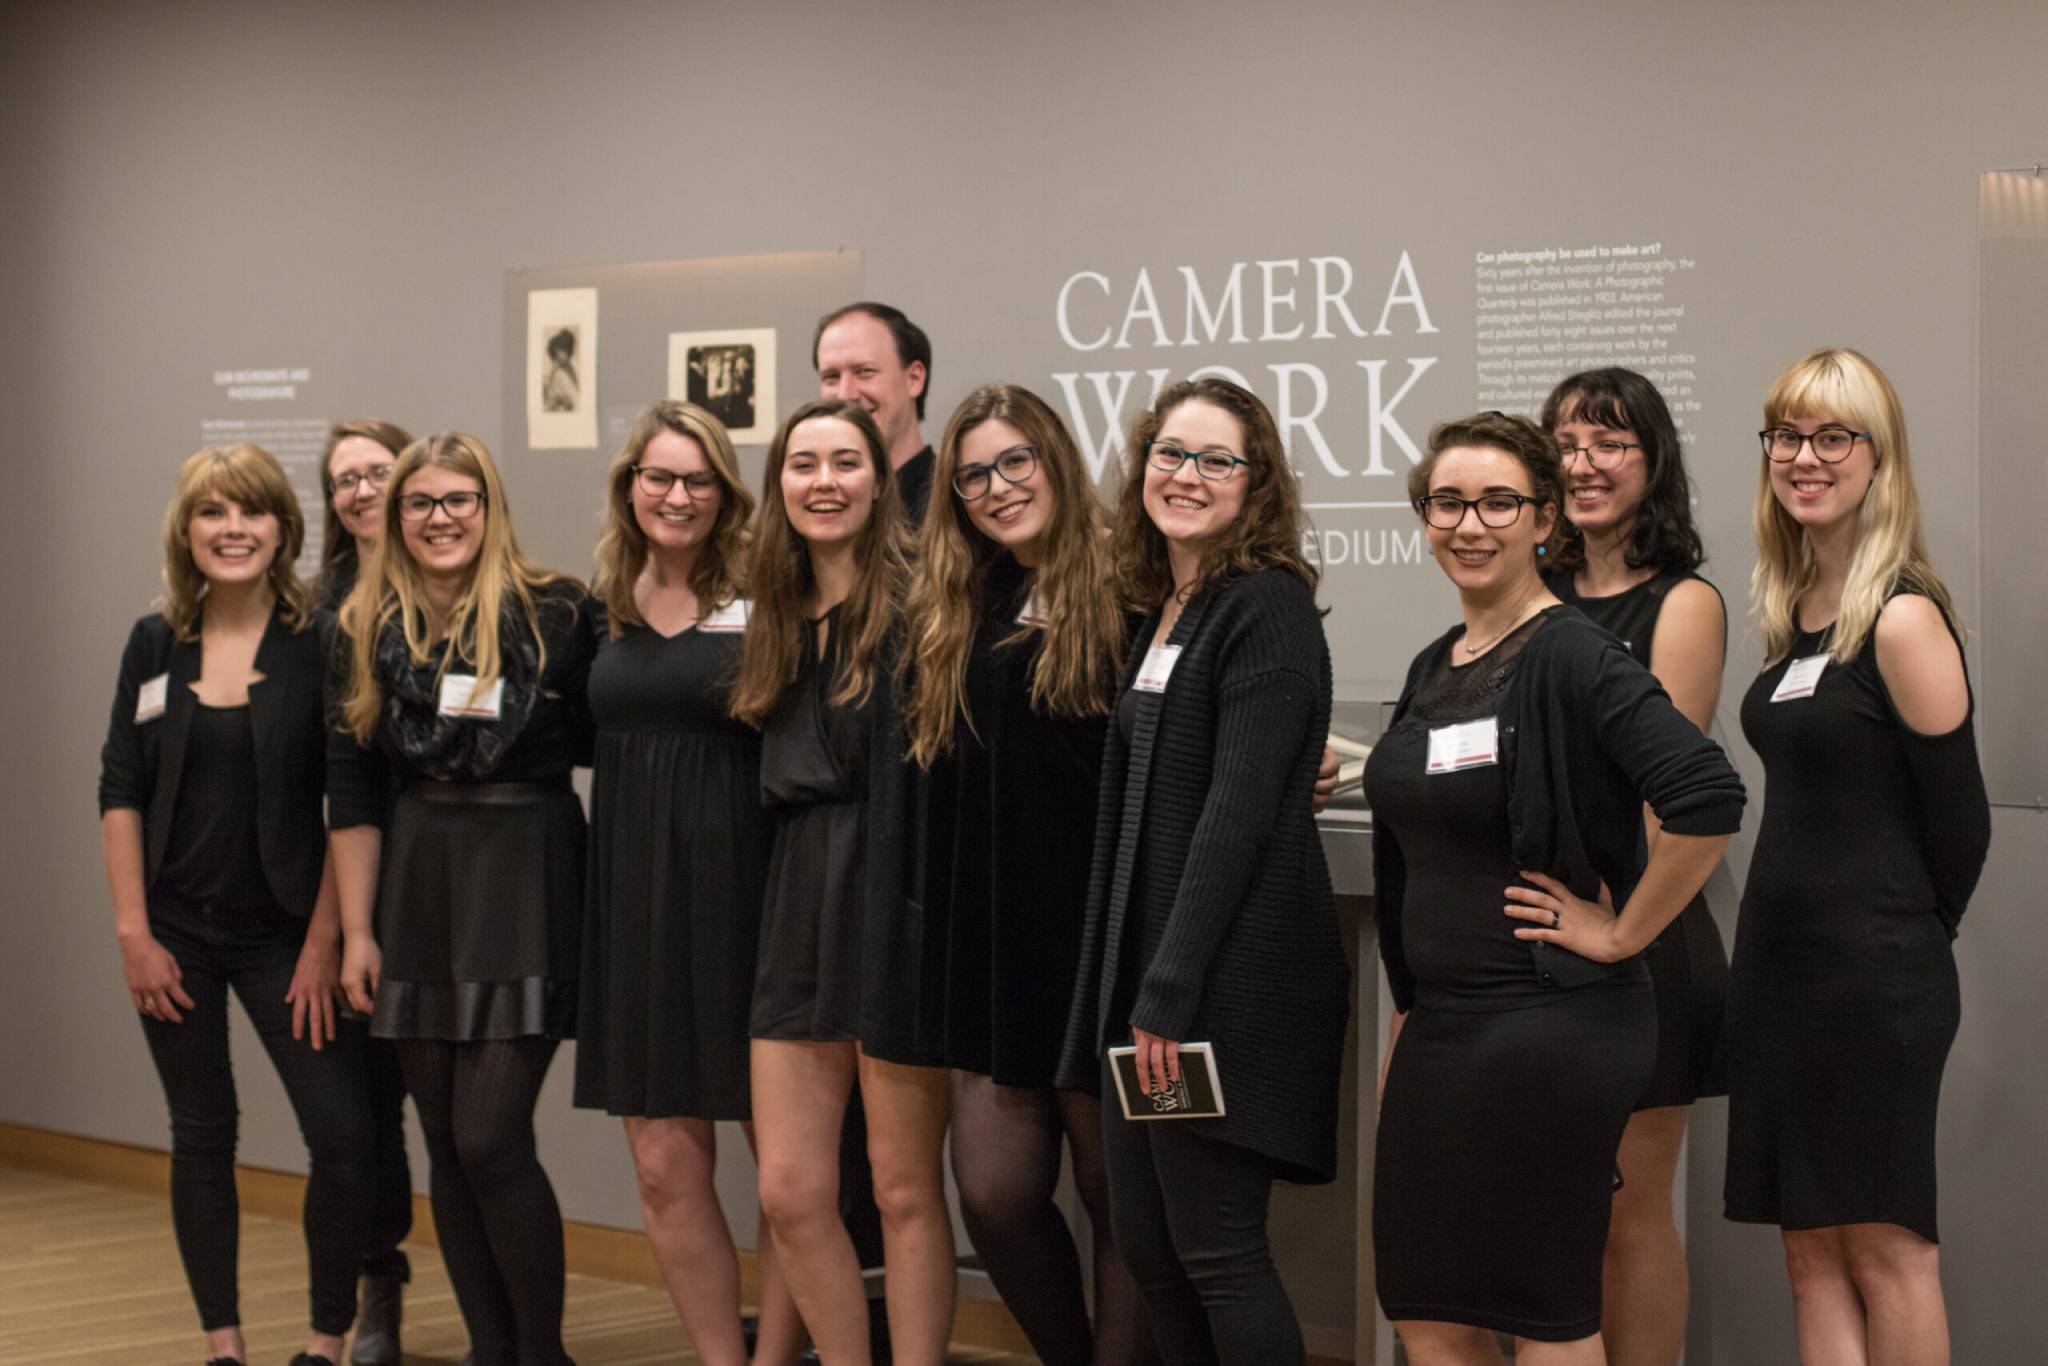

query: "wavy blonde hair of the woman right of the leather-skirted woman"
left=590, top=399, right=754, bottom=639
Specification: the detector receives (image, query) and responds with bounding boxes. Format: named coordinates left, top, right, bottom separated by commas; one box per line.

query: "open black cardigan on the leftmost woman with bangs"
left=100, top=606, right=334, bottom=917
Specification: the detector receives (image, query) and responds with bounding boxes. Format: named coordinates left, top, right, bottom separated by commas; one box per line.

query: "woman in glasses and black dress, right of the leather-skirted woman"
left=575, top=399, right=803, bottom=1366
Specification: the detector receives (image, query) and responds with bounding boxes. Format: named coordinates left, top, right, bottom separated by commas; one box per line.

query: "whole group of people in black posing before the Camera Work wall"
left=100, top=294, right=1989, bottom=1366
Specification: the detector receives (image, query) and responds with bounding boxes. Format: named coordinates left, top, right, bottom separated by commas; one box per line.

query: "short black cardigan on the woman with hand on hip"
left=1372, top=606, right=1743, bottom=1012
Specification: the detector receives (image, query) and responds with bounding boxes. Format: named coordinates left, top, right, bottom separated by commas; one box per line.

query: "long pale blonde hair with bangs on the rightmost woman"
left=1749, top=346, right=1962, bottom=668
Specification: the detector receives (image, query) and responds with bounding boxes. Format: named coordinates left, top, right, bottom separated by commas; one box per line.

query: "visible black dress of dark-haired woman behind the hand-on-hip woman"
left=1544, top=573, right=1729, bottom=1110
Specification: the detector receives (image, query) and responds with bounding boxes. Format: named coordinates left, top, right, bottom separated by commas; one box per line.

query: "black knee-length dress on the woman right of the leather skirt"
left=575, top=627, right=768, bottom=1120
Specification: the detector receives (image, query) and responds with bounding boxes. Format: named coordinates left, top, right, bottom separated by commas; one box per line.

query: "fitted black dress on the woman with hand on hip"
left=1366, top=608, right=1657, bottom=1341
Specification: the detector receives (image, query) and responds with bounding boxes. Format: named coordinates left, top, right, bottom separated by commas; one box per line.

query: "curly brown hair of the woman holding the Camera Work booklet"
left=1114, top=377, right=1321, bottom=606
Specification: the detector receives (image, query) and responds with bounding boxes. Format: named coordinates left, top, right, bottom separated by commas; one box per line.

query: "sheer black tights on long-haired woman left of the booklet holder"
left=952, top=1071, right=1157, bottom=1366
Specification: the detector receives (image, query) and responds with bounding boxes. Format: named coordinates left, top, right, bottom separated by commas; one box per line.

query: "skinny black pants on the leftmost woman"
left=141, top=909, right=369, bottom=1335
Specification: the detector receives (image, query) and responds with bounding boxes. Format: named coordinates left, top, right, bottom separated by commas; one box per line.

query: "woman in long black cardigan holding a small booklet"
left=1061, top=379, right=1350, bottom=1366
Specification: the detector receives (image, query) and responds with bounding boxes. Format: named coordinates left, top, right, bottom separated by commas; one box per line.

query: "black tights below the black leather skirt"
left=397, top=1038, right=569, bottom=1366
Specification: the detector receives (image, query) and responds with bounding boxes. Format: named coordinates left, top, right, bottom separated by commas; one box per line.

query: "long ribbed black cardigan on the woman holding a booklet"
left=1061, top=569, right=1352, bottom=1182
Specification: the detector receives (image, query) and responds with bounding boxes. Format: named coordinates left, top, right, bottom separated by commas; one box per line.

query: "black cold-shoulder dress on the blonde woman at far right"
left=1724, top=606, right=1991, bottom=1241
